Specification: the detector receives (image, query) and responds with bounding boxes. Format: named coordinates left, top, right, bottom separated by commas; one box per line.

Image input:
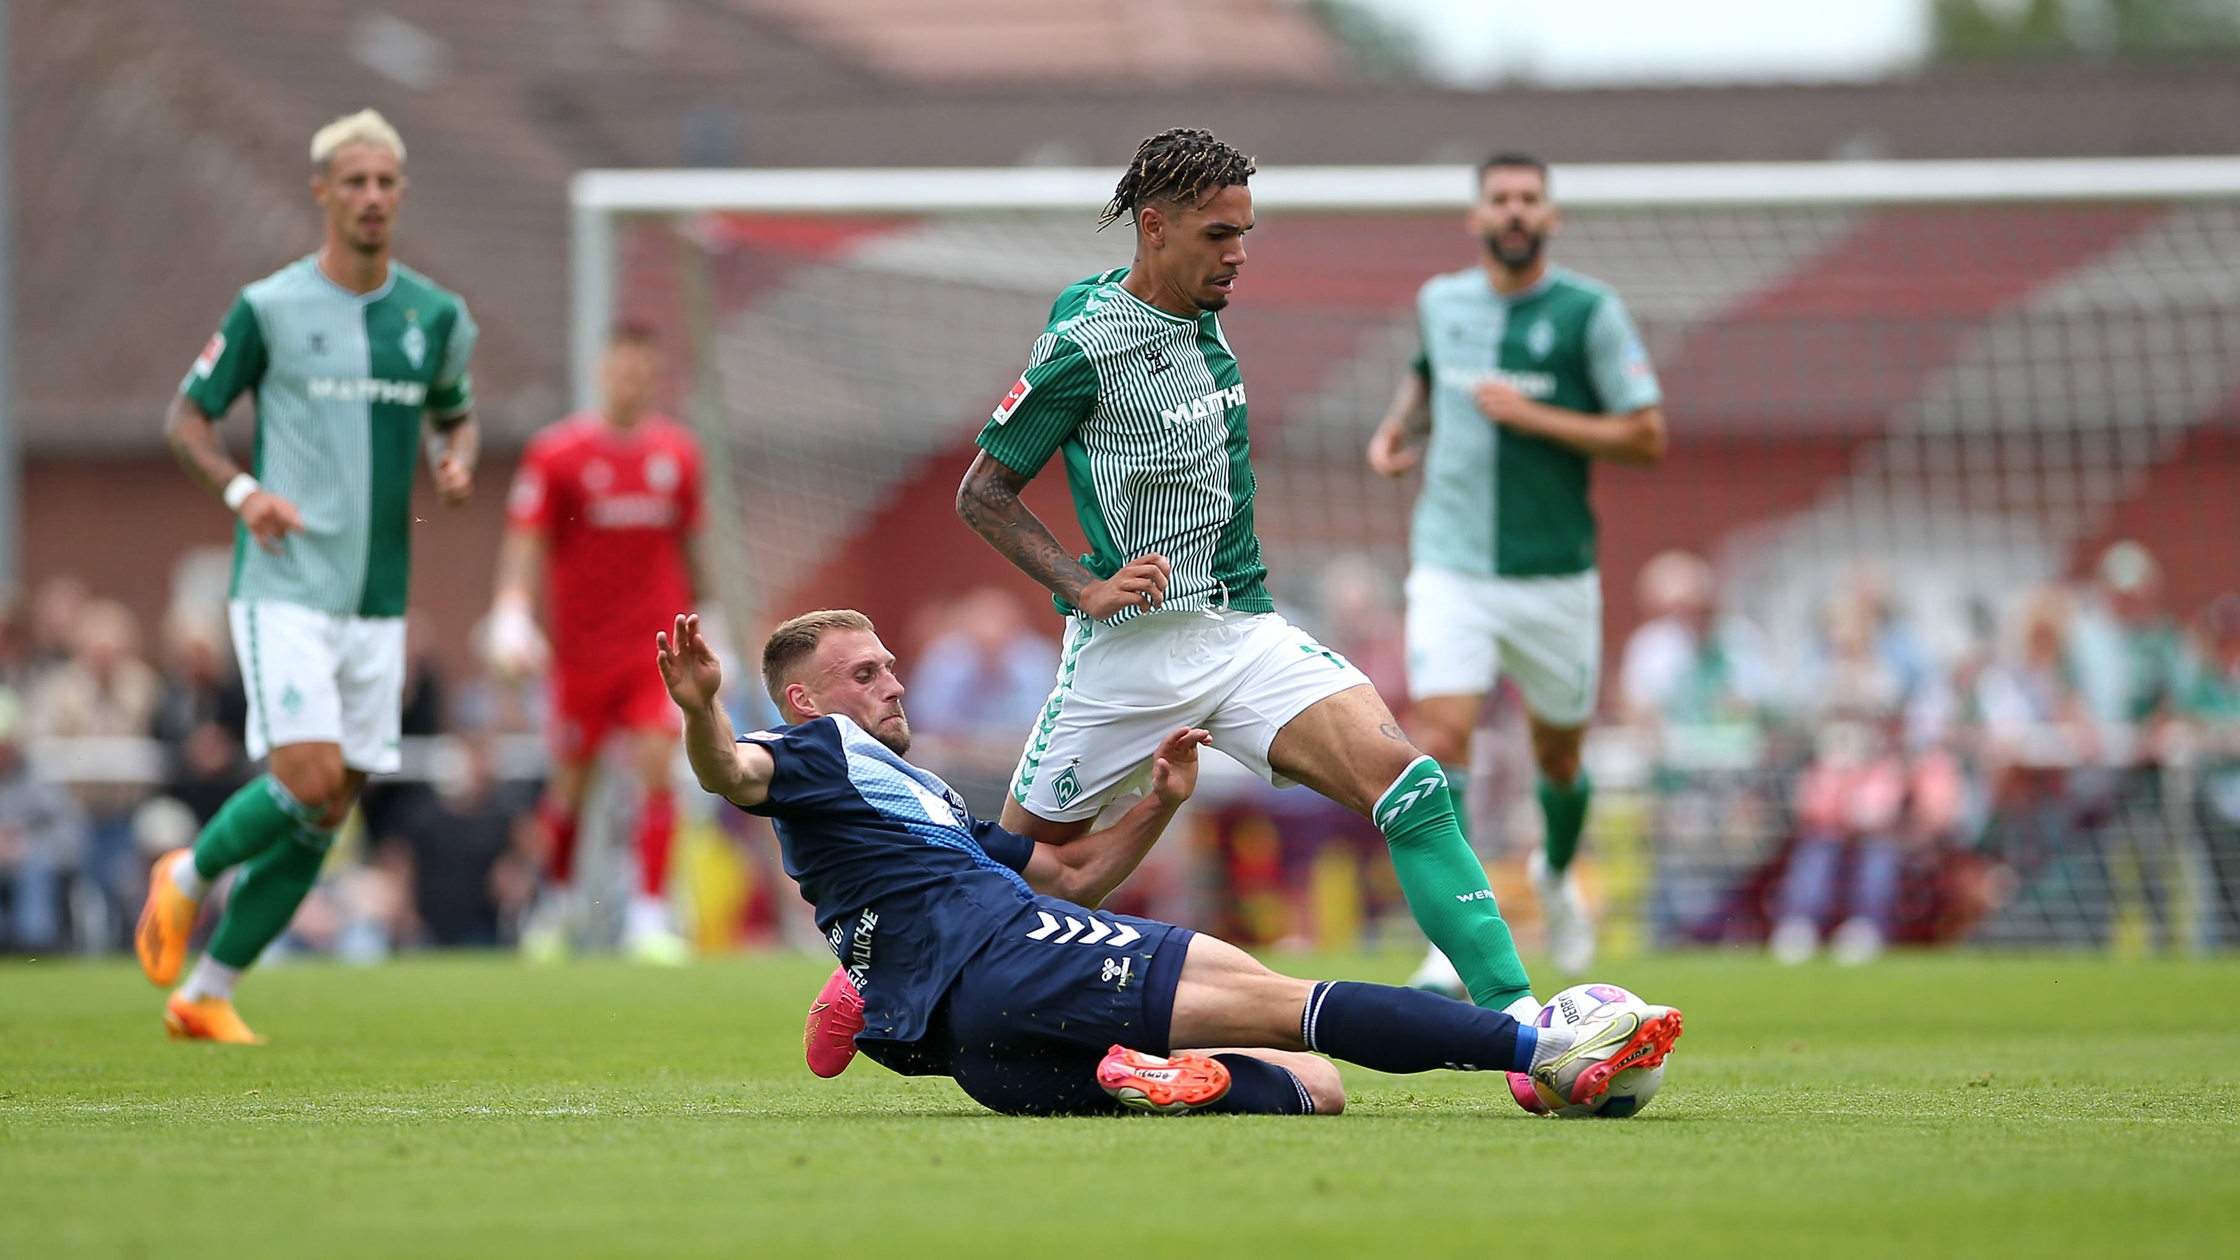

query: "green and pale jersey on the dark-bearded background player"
left=1409, top=267, right=1662, bottom=578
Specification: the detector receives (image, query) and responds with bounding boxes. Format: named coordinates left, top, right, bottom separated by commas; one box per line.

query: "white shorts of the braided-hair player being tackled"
left=1010, top=610, right=1369, bottom=823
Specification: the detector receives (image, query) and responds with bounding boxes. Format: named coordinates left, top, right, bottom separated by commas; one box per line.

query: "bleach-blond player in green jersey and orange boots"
left=134, top=110, right=477, bottom=1043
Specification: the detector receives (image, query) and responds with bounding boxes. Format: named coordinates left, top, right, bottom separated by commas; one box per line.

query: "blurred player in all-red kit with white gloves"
left=491, top=325, right=708, bottom=962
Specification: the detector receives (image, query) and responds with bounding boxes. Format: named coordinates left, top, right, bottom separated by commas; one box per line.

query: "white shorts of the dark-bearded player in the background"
left=1407, top=565, right=1602, bottom=726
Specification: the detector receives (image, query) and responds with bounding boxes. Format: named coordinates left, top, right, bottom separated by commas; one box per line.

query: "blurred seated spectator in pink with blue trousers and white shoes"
left=1770, top=590, right=1964, bottom=964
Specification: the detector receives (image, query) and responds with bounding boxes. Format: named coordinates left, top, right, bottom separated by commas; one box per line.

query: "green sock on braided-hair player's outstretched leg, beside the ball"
left=1371, top=758, right=1532, bottom=1011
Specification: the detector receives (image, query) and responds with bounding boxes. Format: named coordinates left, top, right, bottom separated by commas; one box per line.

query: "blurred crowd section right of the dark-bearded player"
left=1615, top=540, right=2240, bottom=962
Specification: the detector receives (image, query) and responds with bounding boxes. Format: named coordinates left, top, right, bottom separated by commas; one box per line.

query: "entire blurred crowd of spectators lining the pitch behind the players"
left=0, top=543, right=2240, bottom=962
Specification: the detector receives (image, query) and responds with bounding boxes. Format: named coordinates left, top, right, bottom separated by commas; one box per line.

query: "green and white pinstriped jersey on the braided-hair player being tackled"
left=979, top=267, right=1275, bottom=623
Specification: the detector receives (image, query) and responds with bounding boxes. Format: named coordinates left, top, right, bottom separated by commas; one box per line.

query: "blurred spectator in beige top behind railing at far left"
left=29, top=583, right=161, bottom=924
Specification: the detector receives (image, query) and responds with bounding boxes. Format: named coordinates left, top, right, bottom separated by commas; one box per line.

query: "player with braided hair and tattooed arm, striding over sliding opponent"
left=956, top=128, right=1537, bottom=1018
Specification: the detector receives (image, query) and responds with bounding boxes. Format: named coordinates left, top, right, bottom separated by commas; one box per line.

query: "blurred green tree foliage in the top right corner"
left=1933, top=0, right=2240, bottom=61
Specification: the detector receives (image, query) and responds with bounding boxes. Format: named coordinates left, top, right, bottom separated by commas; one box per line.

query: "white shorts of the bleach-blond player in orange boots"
left=226, top=599, right=405, bottom=773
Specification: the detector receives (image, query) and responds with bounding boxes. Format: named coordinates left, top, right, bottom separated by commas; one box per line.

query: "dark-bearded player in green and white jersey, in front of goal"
left=1369, top=152, right=1664, bottom=986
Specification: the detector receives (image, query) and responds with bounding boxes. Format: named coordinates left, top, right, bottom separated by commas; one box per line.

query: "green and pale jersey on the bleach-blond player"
left=179, top=256, right=475, bottom=617
